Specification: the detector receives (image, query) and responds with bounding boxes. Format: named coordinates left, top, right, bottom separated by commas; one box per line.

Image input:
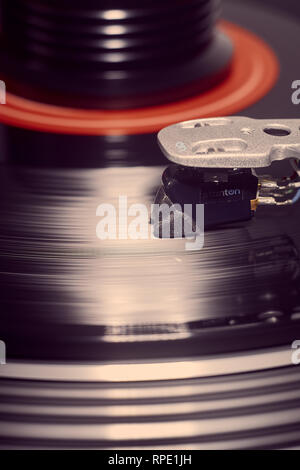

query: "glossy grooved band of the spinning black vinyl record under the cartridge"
left=0, top=162, right=300, bottom=360
